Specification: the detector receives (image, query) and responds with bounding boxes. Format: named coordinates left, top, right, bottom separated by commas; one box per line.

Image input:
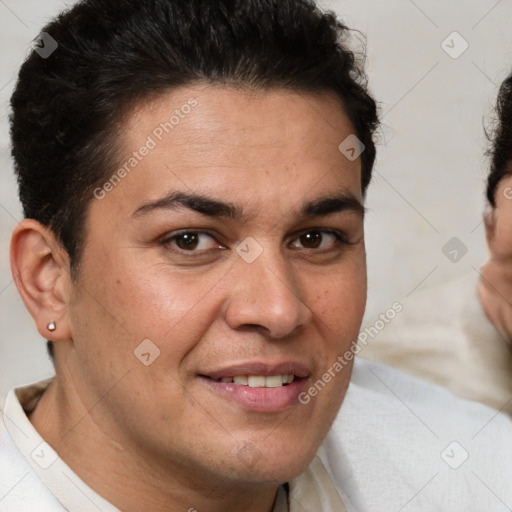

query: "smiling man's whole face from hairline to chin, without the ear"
left=62, top=86, right=366, bottom=488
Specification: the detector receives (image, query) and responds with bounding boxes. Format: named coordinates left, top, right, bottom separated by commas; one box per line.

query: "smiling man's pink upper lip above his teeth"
left=201, top=361, right=311, bottom=379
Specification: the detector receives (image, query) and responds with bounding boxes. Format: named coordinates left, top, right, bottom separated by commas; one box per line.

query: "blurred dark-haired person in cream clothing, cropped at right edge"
left=361, top=75, right=512, bottom=414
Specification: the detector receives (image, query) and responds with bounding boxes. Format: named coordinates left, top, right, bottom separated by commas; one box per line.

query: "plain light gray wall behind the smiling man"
left=0, top=0, right=512, bottom=392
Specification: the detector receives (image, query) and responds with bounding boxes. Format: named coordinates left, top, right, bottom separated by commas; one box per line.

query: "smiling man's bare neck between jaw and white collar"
left=29, top=378, right=277, bottom=512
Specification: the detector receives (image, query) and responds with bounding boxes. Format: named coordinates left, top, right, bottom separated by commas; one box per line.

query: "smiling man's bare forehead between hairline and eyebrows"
left=93, top=85, right=361, bottom=218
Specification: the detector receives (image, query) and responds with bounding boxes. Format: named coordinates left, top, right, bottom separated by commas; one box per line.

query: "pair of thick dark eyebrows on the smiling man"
left=132, top=191, right=365, bottom=221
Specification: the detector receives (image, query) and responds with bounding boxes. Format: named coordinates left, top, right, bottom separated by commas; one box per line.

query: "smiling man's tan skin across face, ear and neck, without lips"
left=12, top=85, right=366, bottom=512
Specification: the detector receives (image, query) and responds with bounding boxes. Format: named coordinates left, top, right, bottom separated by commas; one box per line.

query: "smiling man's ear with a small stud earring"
left=11, top=219, right=72, bottom=341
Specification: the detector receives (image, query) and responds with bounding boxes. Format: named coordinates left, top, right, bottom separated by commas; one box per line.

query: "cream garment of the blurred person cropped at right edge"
left=359, top=271, right=512, bottom=412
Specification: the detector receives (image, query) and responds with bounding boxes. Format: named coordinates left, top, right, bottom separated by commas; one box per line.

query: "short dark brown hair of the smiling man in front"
left=10, top=0, right=378, bottom=360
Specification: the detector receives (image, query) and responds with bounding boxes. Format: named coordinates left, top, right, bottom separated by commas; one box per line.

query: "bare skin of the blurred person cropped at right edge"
left=479, top=173, right=512, bottom=341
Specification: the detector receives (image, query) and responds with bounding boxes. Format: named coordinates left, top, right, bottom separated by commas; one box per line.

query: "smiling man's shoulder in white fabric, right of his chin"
left=321, top=360, right=512, bottom=512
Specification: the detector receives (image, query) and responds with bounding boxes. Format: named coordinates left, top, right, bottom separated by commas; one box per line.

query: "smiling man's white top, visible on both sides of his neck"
left=0, top=360, right=512, bottom=512
